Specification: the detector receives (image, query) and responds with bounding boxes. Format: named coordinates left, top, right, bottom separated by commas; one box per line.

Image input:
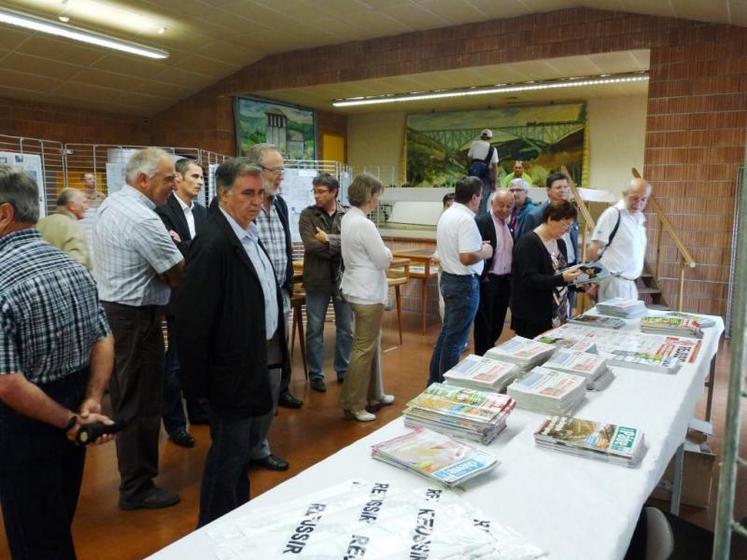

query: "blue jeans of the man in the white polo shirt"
left=428, top=271, right=480, bottom=385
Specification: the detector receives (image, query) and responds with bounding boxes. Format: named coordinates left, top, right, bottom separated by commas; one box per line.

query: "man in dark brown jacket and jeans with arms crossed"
left=298, top=173, right=353, bottom=393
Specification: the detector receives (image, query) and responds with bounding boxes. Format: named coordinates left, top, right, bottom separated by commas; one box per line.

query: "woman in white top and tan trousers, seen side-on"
left=340, top=173, right=394, bottom=422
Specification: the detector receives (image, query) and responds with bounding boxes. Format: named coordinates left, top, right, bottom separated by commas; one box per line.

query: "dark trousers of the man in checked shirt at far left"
left=0, top=368, right=88, bottom=560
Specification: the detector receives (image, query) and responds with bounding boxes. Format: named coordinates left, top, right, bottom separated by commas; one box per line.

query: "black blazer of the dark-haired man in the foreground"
left=176, top=206, right=287, bottom=418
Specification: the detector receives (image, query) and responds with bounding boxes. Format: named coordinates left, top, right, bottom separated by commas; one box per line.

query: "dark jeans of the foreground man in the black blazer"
left=197, top=414, right=260, bottom=527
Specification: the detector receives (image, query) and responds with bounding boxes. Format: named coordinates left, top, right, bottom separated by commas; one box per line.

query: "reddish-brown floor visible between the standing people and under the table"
left=0, top=312, right=747, bottom=560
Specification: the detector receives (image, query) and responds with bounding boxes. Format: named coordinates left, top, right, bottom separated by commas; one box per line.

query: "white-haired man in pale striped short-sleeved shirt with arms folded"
left=93, top=148, right=184, bottom=510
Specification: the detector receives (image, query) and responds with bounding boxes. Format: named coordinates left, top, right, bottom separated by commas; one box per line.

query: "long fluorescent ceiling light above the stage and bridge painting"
left=332, top=72, right=648, bottom=107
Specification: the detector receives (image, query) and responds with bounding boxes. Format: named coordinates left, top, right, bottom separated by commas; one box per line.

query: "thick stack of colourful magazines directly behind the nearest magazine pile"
left=404, top=383, right=516, bottom=444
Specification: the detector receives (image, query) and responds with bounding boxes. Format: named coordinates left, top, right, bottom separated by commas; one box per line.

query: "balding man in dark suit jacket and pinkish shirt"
left=475, top=189, right=514, bottom=356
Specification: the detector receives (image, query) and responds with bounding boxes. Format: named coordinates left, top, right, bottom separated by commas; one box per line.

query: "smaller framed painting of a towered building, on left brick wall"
left=234, top=97, right=316, bottom=160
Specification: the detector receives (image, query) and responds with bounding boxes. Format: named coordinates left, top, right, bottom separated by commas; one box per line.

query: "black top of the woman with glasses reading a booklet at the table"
left=510, top=231, right=567, bottom=328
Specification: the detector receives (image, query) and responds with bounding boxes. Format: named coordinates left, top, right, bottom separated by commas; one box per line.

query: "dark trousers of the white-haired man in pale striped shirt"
left=102, top=302, right=164, bottom=499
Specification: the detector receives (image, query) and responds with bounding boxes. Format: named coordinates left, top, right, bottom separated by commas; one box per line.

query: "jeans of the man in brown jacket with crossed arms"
left=306, top=292, right=353, bottom=379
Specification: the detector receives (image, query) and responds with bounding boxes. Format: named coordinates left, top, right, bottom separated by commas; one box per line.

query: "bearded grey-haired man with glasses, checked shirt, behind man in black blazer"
left=246, top=144, right=296, bottom=471
